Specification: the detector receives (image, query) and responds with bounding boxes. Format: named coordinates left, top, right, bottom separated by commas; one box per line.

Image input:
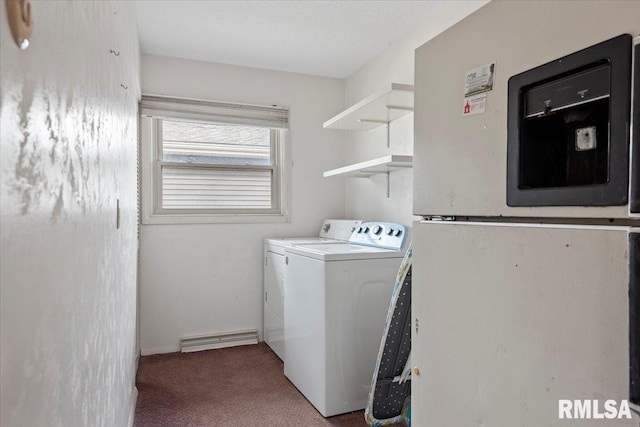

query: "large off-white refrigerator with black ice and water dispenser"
left=412, top=2, right=640, bottom=427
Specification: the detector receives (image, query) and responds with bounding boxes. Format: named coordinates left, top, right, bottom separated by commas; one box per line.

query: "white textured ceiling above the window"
left=135, top=0, right=476, bottom=78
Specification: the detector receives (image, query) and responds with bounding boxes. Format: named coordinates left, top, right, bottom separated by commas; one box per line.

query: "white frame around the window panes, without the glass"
left=140, top=96, right=290, bottom=224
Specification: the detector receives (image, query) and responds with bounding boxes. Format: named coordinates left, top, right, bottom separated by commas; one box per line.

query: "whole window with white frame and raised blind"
left=141, top=95, right=289, bottom=224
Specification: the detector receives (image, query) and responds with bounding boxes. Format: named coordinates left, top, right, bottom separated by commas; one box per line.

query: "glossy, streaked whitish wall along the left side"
left=0, top=1, right=140, bottom=427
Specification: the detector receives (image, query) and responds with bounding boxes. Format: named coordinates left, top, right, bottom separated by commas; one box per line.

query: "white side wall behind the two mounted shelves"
left=345, top=0, right=487, bottom=225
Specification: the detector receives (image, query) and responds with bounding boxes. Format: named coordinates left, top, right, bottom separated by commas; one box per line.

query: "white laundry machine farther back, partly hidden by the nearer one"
left=263, top=219, right=362, bottom=360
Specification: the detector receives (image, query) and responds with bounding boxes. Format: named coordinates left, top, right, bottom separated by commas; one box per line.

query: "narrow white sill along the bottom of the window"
left=142, top=214, right=289, bottom=225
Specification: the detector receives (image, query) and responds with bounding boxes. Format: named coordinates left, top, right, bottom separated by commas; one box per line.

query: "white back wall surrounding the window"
left=140, top=55, right=344, bottom=354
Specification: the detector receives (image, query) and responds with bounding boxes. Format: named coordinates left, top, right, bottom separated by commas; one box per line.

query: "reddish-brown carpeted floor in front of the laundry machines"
left=134, top=343, right=392, bottom=427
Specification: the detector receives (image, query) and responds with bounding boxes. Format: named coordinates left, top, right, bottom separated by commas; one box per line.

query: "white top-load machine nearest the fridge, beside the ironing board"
left=284, top=223, right=406, bottom=417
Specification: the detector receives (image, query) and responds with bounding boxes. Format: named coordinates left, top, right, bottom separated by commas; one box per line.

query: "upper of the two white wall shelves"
left=323, top=83, right=413, bottom=130
